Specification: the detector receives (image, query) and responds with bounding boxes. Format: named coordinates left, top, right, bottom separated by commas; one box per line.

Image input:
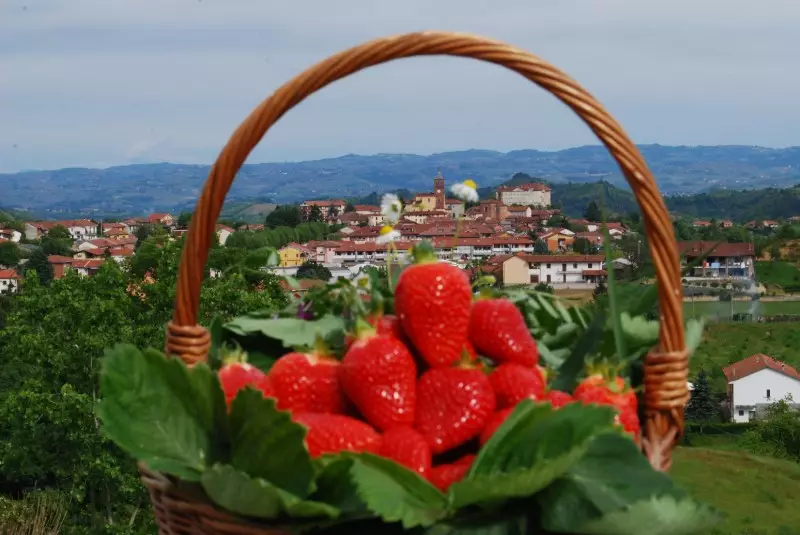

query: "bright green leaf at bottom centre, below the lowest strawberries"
left=350, top=453, right=448, bottom=529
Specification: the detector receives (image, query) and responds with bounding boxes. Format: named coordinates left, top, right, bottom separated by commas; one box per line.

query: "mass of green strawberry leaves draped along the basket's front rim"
left=98, top=345, right=717, bottom=535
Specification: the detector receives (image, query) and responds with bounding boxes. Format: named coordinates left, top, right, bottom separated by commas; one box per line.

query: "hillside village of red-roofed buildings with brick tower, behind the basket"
left=0, top=174, right=777, bottom=292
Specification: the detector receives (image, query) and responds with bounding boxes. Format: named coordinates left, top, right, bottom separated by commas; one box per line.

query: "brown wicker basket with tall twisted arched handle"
left=148, top=32, right=689, bottom=535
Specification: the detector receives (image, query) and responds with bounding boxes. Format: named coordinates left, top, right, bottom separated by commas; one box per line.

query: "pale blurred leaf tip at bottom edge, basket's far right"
left=573, top=496, right=721, bottom=535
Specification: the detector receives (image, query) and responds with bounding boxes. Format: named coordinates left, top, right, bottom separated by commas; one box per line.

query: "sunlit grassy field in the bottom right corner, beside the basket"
left=672, top=447, right=800, bottom=535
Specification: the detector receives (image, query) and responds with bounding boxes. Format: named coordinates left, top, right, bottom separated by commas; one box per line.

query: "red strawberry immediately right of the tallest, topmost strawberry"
left=469, top=299, right=539, bottom=367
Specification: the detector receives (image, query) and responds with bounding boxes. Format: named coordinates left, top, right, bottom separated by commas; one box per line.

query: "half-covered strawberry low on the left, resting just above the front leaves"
left=293, top=412, right=381, bottom=457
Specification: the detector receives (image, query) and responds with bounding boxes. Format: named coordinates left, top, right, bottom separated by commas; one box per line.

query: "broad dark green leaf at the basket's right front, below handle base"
left=536, top=434, right=684, bottom=533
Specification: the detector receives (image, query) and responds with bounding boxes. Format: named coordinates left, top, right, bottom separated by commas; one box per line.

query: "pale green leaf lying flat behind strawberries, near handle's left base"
left=225, top=315, right=345, bottom=348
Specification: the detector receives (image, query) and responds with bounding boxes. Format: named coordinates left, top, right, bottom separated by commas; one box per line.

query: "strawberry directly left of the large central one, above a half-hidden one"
left=269, top=351, right=346, bottom=414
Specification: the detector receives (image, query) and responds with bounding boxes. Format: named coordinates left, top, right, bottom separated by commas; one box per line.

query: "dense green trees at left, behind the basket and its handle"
left=0, top=244, right=287, bottom=535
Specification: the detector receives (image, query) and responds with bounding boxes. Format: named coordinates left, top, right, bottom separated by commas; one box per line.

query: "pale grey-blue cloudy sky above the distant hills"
left=0, top=0, right=800, bottom=172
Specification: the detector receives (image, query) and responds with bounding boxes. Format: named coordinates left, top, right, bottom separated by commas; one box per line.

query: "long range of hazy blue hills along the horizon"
left=0, top=145, right=800, bottom=217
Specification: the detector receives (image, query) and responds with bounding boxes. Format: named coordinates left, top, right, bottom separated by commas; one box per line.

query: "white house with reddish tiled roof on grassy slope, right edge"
left=722, top=353, right=800, bottom=422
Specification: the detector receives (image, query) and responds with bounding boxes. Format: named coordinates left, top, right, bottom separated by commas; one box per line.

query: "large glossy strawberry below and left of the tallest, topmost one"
left=339, top=324, right=417, bottom=431
